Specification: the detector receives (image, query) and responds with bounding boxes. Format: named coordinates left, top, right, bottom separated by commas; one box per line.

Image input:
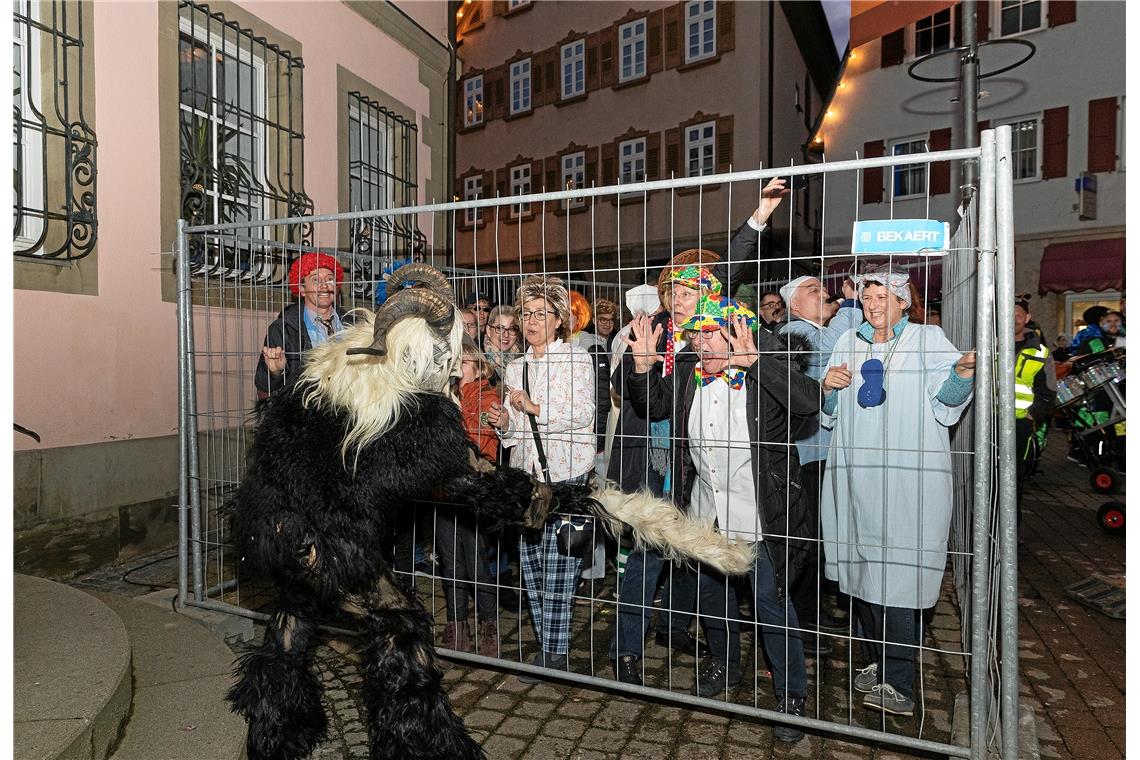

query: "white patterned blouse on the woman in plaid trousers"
left=499, top=340, right=597, bottom=482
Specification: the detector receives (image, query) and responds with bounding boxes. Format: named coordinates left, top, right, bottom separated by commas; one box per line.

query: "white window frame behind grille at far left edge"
left=11, top=2, right=47, bottom=253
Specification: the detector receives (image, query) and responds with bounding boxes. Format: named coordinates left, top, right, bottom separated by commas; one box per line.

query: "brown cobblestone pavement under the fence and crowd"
left=75, top=436, right=1124, bottom=760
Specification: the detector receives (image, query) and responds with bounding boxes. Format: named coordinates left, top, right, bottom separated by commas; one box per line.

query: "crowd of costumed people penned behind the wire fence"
left=257, top=179, right=998, bottom=742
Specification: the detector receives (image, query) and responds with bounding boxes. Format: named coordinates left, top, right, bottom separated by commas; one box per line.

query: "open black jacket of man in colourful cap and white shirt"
left=626, top=330, right=820, bottom=589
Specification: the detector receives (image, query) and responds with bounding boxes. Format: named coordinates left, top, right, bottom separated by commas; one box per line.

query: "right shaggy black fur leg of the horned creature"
left=351, top=562, right=486, bottom=760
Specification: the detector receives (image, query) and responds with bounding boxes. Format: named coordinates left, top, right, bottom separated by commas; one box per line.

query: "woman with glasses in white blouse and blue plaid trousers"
left=488, top=276, right=595, bottom=683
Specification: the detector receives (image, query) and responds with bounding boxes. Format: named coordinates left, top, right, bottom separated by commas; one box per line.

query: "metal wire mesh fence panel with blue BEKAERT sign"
left=174, top=133, right=1016, bottom=757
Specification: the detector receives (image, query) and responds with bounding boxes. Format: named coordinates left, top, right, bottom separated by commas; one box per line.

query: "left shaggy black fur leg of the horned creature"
left=226, top=610, right=328, bottom=760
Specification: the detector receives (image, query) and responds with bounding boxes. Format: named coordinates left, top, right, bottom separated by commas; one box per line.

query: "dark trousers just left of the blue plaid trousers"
left=435, top=509, right=498, bottom=622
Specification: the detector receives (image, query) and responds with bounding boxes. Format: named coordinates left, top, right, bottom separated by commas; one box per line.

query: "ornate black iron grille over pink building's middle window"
left=178, top=0, right=312, bottom=284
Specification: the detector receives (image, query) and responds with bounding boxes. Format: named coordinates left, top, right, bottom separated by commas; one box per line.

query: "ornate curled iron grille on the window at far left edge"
left=13, top=0, right=98, bottom=261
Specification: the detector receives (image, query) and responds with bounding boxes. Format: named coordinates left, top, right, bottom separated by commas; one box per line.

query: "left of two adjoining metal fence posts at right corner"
left=970, top=130, right=996, bottom=760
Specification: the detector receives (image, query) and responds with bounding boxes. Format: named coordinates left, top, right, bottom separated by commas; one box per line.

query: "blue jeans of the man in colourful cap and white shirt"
left=697, top=544, right=807, bottom=698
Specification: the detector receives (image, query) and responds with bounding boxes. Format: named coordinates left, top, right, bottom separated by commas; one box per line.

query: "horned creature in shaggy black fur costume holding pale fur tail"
left=229, top=264, right=750, bottom=760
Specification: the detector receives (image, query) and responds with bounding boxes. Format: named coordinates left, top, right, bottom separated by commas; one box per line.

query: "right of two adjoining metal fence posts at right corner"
left=995, top=126, right=1020, bottom=760
